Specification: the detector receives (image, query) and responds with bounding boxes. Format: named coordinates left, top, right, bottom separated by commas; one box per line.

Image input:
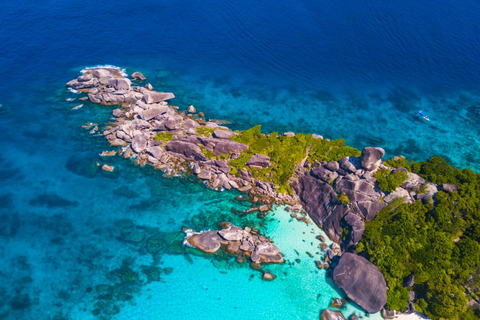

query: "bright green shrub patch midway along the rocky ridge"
left=230, top=126, right=361, bottom=194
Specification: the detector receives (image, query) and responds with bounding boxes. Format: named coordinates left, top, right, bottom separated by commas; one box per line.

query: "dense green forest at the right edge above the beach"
left=357, top=157, right=480, bottom=320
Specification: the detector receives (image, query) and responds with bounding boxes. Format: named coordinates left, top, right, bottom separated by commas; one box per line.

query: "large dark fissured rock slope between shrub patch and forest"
left=292, top=157, right=387, bottom=248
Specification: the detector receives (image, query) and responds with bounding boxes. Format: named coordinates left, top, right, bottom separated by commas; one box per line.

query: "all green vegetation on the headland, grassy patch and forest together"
left=163, top=125, right=480, bottom=320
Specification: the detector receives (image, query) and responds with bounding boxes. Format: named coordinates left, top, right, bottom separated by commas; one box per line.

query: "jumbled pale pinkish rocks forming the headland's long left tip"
left=67, top=68, right=295, bottom=208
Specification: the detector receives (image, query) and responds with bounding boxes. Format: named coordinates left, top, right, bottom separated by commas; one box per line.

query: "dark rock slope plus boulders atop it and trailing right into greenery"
left=292, top=147, right=438, bottom=250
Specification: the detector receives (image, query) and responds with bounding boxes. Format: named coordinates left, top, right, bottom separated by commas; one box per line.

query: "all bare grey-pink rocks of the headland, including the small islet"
left=67, top=68, right=456, bottom=319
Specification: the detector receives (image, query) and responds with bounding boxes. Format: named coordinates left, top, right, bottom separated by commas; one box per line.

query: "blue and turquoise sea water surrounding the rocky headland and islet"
left=0, top=0, right=480, bottom=320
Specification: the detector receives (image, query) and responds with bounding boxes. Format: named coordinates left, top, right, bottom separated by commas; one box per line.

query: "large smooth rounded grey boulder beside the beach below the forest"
left=333, top=252, right=387, bottom=313
